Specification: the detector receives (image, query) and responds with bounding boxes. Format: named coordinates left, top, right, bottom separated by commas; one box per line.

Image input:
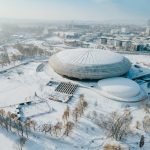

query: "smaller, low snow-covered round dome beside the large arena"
left=98, top=77, right=147, bottom=102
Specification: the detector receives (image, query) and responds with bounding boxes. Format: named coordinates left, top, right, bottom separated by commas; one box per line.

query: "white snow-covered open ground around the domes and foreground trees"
left=0, top=55, right=150, bottom=150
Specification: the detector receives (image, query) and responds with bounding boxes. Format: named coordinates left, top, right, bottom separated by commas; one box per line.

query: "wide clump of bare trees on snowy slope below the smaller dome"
left=88, top=111, right=132, bottom=140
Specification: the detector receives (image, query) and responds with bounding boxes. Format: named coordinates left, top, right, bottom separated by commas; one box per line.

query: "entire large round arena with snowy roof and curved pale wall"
left=49, top=49, right=131, bottom=79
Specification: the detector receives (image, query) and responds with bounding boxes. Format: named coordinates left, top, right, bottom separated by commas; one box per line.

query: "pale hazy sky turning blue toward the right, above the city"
left=0, top=0, right=150, bottom=21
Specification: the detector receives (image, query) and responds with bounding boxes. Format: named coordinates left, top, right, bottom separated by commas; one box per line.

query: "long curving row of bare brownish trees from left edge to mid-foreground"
left=0, top=95, right=87, bottom=138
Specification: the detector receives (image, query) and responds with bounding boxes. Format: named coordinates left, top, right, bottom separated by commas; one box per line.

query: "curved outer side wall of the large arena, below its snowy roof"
left=49, top=49, right=131, bottom=79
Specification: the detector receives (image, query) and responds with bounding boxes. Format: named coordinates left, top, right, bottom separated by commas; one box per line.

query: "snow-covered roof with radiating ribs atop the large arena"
left=57, top=48, right=123, bottom=65
